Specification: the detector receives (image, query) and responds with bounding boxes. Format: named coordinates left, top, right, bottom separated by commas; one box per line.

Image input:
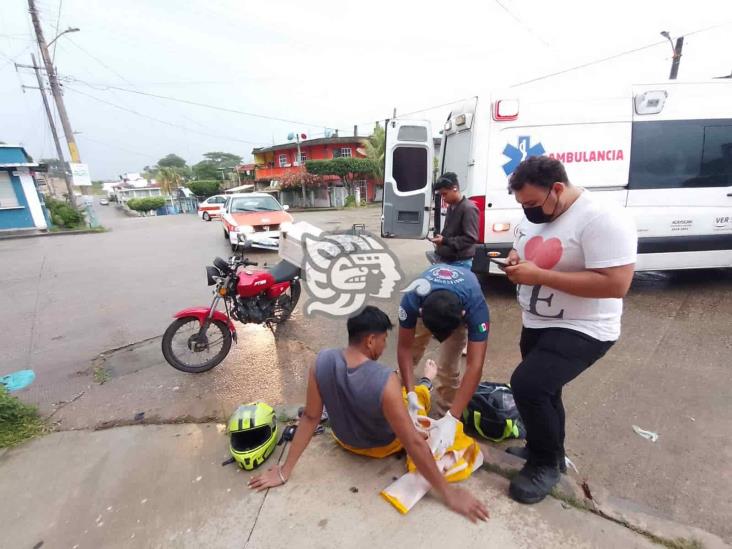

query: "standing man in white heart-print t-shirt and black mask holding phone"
left=505, top=156, right=638, bottom=503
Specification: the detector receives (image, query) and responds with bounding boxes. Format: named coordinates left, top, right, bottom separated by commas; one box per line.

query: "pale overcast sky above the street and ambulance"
left=0, top=0, right=732, bottom=179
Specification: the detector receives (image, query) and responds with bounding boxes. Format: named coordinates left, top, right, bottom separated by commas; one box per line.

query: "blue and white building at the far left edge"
left=0, top=145, right=48, bottom=230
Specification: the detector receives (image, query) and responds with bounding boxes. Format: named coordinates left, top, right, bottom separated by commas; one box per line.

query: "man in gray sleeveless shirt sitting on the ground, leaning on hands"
left=249, top=306, right=488, bottom=522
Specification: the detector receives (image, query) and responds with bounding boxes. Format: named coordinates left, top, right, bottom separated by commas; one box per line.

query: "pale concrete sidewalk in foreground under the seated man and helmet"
left=0, top=424, right=724, bottom=549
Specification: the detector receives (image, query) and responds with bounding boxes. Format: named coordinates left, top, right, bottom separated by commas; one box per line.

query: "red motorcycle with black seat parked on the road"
left=163, top=256, right=301, bottom=373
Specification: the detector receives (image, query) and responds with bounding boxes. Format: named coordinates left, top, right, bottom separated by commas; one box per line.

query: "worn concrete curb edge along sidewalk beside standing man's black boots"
left=479, top=441, right=729, bottom=549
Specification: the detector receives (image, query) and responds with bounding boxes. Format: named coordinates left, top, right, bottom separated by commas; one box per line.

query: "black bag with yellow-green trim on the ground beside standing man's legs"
left=462, top=381, right=526, bottom=442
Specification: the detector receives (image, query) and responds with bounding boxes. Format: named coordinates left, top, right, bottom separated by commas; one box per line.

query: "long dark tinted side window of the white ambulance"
left=629, top=120, right=732, bottom=189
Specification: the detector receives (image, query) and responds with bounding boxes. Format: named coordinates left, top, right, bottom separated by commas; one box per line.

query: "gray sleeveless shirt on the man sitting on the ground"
left=315, top=349, right=395, bottom=448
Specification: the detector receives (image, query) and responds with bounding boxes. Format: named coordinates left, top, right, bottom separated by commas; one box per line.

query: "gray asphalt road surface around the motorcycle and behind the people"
left=0, top=200, right=732, bottom=541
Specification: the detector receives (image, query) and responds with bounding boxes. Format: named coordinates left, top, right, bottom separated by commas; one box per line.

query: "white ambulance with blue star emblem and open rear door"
left=381, top=79, right=732, bottom=273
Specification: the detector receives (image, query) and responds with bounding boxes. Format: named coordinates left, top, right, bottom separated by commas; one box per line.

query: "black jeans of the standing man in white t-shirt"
left=511, top=328, right=615, bottom=465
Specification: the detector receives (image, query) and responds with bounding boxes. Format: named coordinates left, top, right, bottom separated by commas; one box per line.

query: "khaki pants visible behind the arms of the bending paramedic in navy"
left=412, top=319, right=468, bottom=418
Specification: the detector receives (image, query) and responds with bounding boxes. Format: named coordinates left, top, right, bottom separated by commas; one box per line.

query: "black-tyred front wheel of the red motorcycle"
left=162, top=316, right=231, bottom=374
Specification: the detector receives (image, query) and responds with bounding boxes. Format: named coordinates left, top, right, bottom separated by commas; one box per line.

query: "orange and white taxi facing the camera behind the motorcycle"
left=221, top=193, right=292, bottom=250
